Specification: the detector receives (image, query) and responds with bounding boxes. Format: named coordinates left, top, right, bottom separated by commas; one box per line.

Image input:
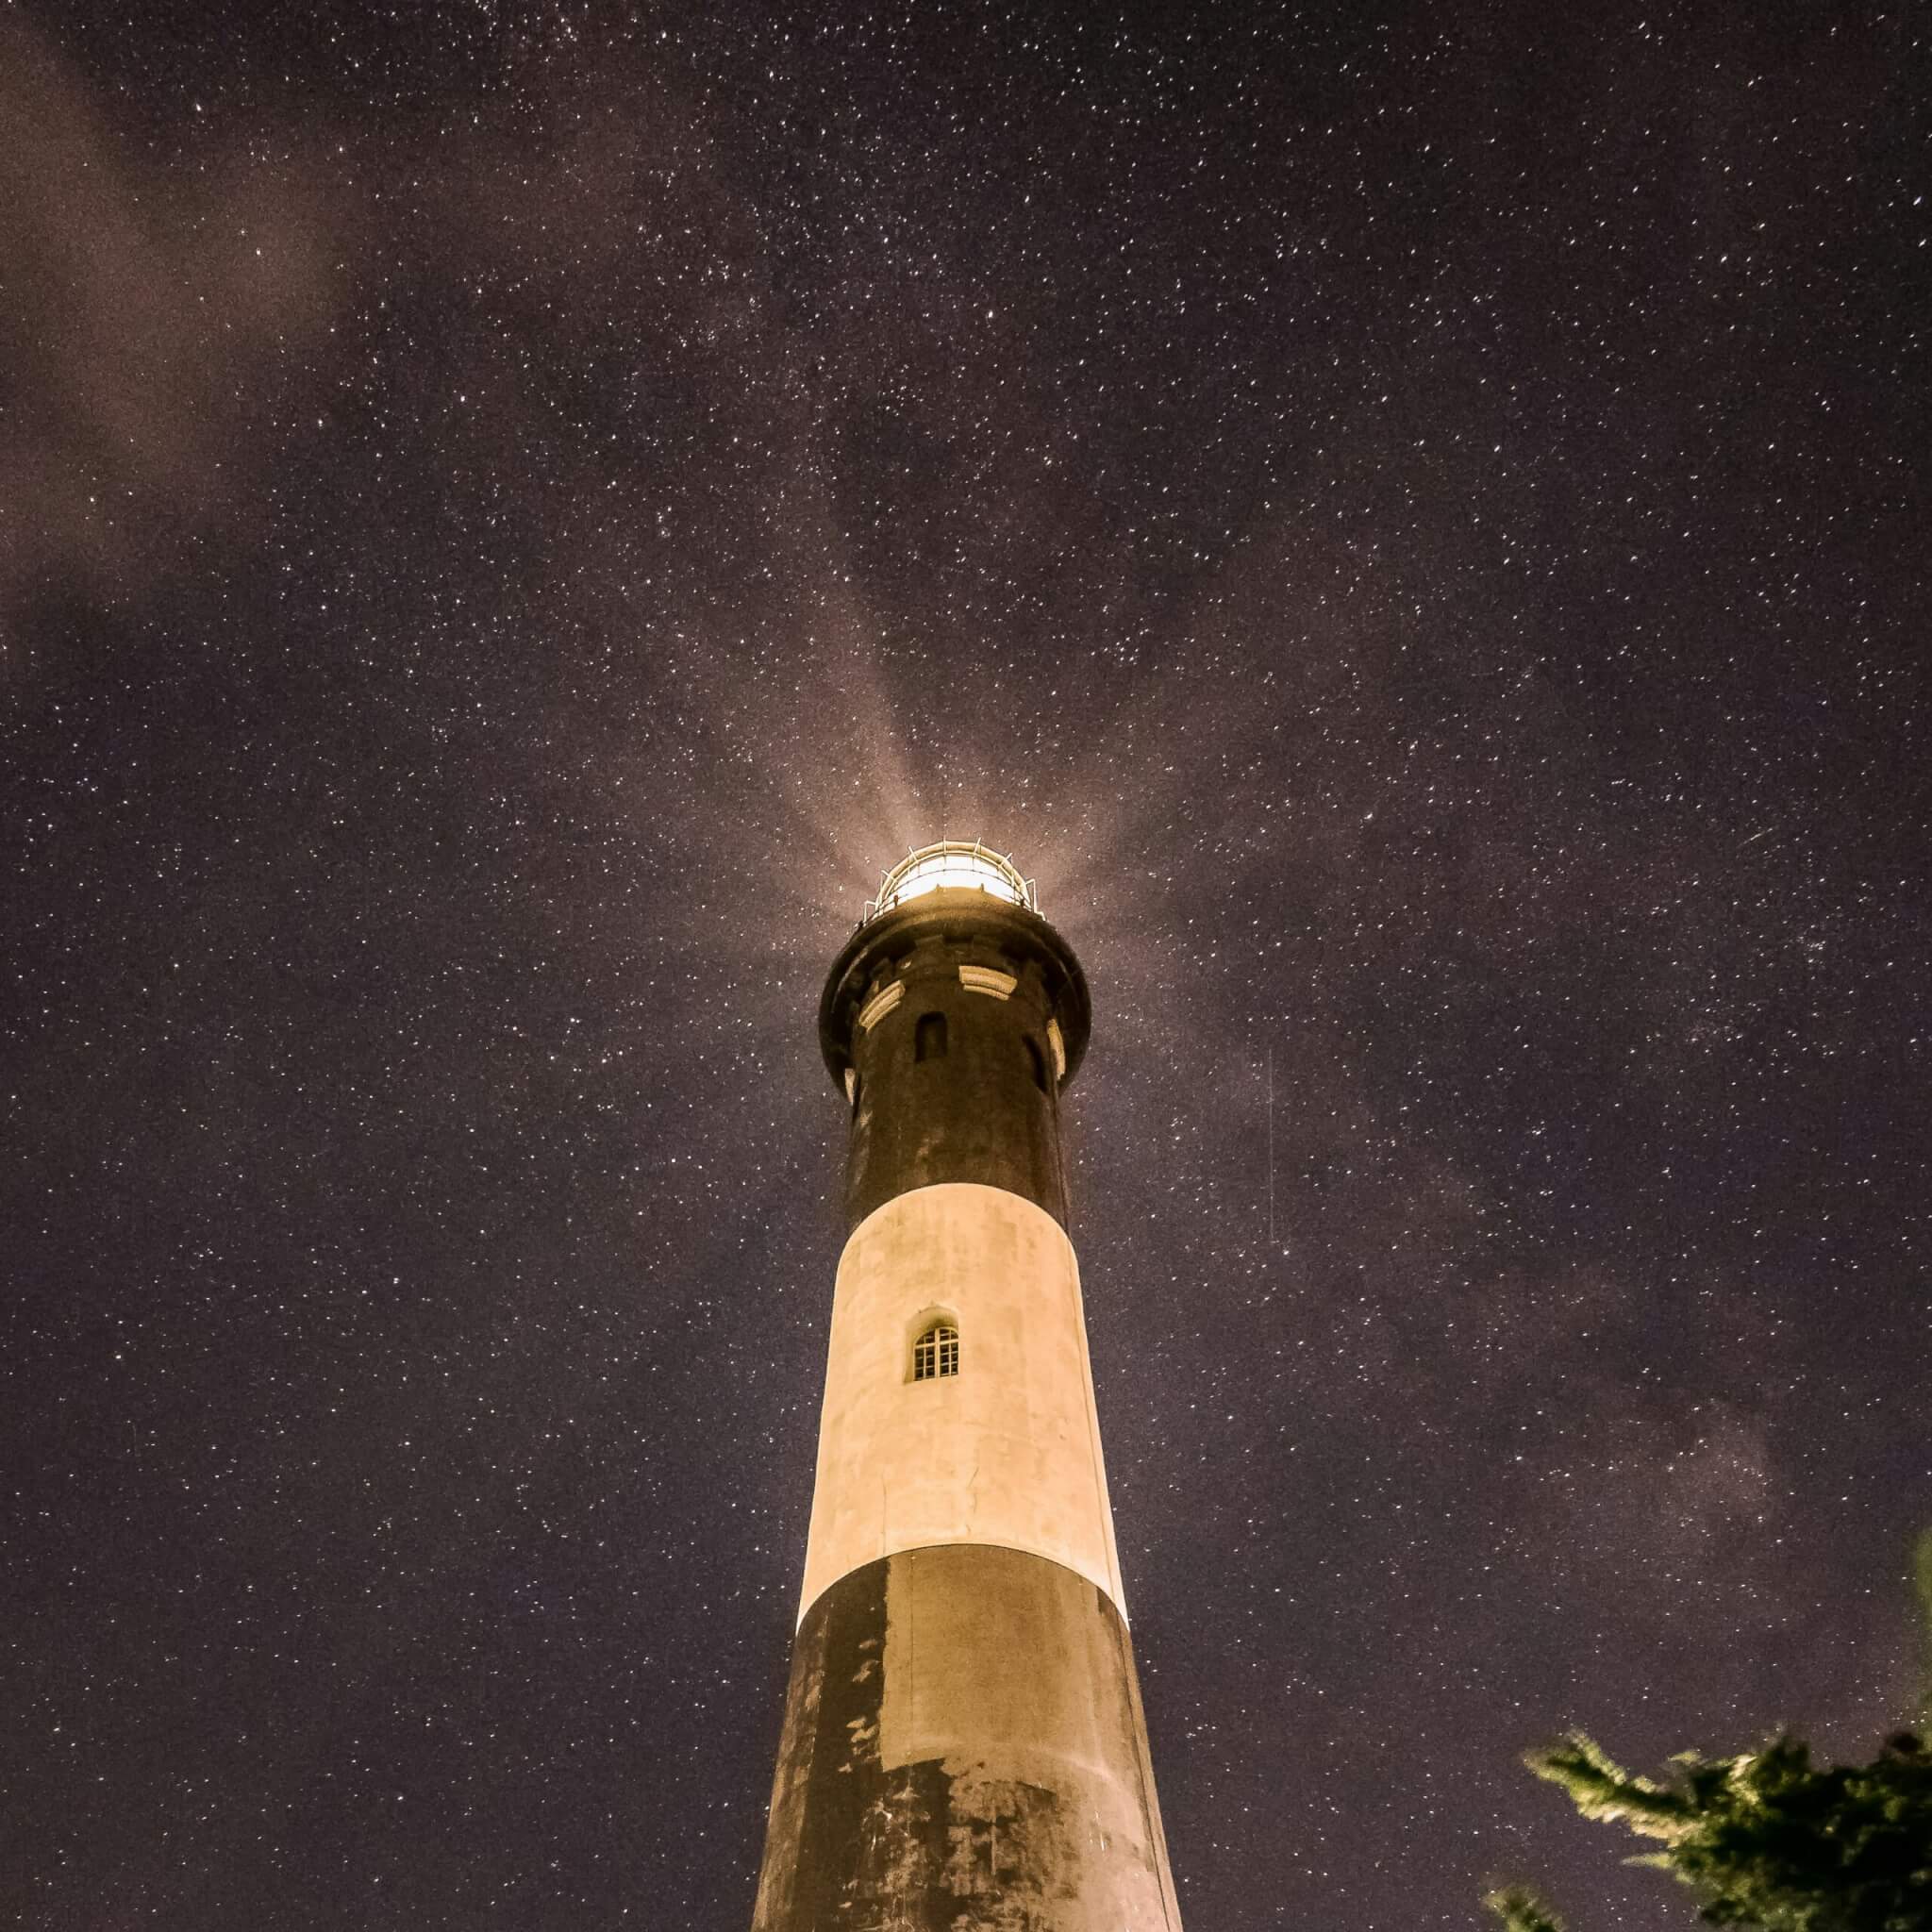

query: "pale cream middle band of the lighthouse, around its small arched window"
left=800, top=1182, right=1126, bottom=1617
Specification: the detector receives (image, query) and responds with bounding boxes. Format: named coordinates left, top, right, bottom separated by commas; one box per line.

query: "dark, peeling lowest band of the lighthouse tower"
left=754, top=1545, right=1180, bottom=1932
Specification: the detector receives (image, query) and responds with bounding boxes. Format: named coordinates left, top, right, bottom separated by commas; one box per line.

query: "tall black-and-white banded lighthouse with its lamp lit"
left=754, top=844, right=1180, bottom=1932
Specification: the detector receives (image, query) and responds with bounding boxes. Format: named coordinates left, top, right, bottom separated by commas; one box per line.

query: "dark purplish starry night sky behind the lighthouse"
left=0, top=0, right=1932, bottom=1932
